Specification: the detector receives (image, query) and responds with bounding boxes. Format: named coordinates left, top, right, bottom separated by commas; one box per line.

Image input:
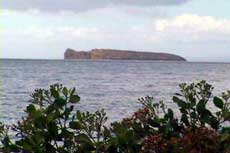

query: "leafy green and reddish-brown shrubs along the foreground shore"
left=0, top=81, right=230, bottom=153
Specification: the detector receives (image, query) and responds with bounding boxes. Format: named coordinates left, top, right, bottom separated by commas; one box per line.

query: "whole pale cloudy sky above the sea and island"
left=0, top=0, right=230, bottom=62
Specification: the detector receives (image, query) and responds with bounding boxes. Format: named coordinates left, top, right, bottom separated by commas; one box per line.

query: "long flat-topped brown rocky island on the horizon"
left=64, top=49, right=186, bottom=61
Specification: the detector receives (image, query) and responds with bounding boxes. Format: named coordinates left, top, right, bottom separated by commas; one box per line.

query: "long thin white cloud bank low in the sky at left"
left=2, top=26, right=99, bottom=41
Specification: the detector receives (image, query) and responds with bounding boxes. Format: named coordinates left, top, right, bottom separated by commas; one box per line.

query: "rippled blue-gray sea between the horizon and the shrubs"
left=0, top=59, right=230, bottom=123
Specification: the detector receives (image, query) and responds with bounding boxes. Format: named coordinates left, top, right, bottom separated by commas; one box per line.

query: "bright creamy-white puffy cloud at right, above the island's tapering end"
left=155, top=14, right=230, bottom=34
